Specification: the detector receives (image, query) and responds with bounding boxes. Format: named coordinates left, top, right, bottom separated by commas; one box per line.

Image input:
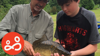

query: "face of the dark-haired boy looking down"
left=61, top=0, right=80, bottom=17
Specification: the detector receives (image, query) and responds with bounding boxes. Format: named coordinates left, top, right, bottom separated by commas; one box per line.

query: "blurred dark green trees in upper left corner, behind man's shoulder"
left=0, top=0, right=30, bottom=21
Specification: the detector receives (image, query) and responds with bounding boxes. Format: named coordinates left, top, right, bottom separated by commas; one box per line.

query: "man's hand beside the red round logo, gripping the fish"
left=23, top=40, right=40, bottom=56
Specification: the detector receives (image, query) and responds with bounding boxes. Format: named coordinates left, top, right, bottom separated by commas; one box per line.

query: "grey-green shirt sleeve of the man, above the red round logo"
left=0, top=6, right=17, bottom=39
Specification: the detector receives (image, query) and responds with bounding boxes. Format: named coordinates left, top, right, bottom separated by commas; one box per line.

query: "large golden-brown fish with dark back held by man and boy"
left=32, top=34, right=71, bottom=56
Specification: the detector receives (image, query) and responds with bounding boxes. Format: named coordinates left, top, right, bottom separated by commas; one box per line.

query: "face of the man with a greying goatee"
left=31, top=0, right=48, bottom=11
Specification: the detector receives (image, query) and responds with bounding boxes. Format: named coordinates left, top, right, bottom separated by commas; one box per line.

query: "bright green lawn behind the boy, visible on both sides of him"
left=51, top=8, right=100, bottom=56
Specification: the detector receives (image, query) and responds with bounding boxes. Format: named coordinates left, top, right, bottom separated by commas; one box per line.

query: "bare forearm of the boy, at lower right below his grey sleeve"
left=71, top=44, right=97, bottom=56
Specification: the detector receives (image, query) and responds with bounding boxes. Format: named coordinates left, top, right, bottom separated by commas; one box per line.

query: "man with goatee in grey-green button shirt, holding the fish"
left=0, top=0, right=53, bottom=56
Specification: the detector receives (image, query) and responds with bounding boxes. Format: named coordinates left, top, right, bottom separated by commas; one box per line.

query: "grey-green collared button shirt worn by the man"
left=0, top=4, right=53, bottom=56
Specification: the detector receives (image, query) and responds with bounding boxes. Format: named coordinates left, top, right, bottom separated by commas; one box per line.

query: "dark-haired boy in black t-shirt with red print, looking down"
left=54, top=0, right=100, bottom=56
